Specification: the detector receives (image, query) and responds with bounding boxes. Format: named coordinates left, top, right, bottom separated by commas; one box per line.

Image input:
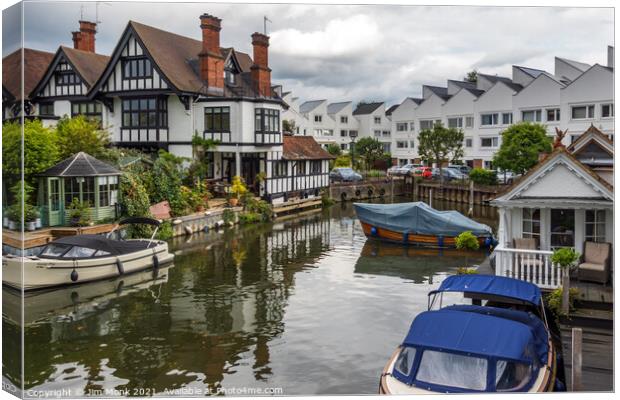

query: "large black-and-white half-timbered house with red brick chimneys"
left=14, top=14, right=329, bottom=200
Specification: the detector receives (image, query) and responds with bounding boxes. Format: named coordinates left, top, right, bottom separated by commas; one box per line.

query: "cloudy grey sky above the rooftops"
left=2, top=2, right=614, bottom=105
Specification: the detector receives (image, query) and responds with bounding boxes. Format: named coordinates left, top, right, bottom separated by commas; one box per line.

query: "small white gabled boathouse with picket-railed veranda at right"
left=491, top=125, right=614, bottom=288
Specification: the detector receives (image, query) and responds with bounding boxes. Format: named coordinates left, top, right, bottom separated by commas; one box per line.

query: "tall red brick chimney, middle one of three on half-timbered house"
left=198, top=14, right=224, bottom=91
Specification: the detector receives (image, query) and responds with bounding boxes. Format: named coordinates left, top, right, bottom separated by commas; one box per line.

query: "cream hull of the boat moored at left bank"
left=2, top=241, right=174, bottom=290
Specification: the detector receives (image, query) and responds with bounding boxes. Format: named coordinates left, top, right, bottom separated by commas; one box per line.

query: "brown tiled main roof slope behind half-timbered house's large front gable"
left=129, top=21, right=257, bottom=96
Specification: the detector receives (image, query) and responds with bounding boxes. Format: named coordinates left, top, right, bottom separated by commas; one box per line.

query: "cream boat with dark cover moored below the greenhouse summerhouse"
left=2, top=218, right=174, bottom=290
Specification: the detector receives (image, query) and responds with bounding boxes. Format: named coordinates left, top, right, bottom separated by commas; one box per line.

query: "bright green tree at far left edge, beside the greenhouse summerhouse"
left=2, top=120, right=59, bottom=187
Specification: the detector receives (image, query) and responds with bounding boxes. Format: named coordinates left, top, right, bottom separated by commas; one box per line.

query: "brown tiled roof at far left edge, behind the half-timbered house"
left=2, top=49, right=54, bottom=100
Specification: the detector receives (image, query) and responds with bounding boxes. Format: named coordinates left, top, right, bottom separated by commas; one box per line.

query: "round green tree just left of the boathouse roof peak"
left=493, top=122, right=552, bottom=174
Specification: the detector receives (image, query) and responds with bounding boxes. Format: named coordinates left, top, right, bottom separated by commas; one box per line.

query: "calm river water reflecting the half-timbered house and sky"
left=3, top=198, right=497, bottom=396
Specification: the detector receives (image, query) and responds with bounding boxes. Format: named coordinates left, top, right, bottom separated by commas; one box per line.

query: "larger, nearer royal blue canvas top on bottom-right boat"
left=403, top=309, right=547, bottom=364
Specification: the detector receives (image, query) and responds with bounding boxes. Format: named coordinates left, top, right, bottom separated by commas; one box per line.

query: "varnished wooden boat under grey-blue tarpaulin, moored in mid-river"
left=354, top=201, right=496, bottom=248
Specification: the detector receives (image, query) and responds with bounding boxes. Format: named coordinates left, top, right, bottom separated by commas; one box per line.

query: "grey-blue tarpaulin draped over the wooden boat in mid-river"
left=354, top=201, right=493, bottom=236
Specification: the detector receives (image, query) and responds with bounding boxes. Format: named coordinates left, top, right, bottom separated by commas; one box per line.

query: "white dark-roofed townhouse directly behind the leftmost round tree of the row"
left=353, top=102, right=392, bottom=153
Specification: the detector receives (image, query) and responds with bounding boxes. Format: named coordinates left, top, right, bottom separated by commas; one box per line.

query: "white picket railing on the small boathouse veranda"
left=493, top=246, right=564, bottom=289
